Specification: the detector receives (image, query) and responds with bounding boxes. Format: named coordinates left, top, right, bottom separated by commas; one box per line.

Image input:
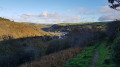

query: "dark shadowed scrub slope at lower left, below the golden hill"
left=0, top=36, right=50, bottom=67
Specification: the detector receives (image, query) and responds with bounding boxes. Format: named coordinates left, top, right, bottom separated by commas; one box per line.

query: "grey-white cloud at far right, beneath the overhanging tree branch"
left=98, top=6, right=120, bottom=21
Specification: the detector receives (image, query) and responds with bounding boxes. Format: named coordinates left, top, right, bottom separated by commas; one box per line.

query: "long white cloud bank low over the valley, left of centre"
left=10, top=11, right=81, bottom=24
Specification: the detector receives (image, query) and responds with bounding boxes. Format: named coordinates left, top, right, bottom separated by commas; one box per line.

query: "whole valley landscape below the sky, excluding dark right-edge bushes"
left=0, top=18, right=119, bottom=67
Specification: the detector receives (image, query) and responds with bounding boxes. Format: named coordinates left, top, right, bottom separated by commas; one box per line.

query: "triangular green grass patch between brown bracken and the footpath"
left=63, top=43, right=99, bottom=67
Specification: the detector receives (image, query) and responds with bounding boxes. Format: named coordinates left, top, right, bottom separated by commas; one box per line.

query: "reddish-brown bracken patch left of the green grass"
left=20, top=48, right=82, bottom=67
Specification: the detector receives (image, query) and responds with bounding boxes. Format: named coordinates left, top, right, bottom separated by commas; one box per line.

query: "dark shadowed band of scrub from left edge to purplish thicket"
left=0, top=22, right=106, bottom=67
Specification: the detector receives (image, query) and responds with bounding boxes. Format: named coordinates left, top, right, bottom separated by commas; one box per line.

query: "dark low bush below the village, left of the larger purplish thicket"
left=46, top=39, right=70, bottom=54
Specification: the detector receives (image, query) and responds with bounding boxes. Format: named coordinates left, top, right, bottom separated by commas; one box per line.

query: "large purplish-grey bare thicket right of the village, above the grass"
left=68, top=26, right=106, bottom=47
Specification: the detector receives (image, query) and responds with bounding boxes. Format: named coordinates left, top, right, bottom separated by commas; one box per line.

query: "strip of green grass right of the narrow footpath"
left=95, top=39, right=115, bottom=67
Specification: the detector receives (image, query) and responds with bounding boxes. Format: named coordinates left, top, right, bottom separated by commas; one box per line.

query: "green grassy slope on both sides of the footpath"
left=64, top=39, right=114, bottom=67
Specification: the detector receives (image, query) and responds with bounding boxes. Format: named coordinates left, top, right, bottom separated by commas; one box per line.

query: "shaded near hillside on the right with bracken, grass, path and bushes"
left=20, top=21, right=120, bottom=67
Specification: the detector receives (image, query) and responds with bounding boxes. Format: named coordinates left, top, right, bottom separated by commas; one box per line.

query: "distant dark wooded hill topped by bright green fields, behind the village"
left=43, top=22, right=109, bottom=32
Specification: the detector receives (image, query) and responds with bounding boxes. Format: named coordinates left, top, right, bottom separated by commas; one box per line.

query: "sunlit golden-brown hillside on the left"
left=0, top=18, right=50, bottom=40
